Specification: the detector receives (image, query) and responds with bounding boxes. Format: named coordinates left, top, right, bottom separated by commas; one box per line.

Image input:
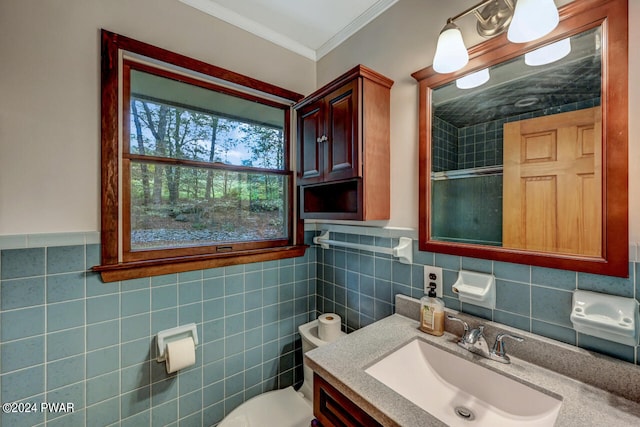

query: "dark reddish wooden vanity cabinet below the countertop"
left=313, top=373, right=382, bottom=427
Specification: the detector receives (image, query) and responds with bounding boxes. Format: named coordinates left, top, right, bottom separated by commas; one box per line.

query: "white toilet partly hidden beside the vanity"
left=218, top=320, right=345, bottom=427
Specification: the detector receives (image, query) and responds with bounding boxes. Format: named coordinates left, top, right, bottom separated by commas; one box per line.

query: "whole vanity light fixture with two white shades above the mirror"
left=433, top=0, right=559, bottom=73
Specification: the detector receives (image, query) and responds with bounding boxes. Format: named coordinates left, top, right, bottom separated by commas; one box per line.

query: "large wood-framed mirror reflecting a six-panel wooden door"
left=413, top=0, right=628, bottom=276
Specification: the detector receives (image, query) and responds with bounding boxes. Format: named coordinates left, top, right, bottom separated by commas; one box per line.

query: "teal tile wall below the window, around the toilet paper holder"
left=0, top=239, right=316, bottom=427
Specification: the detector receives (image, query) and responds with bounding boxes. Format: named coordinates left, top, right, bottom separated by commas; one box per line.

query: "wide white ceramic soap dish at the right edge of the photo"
left=571, top=291, right=639, bottom=346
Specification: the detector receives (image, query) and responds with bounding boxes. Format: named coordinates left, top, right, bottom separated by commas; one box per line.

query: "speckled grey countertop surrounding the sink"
left=305, top=314, right=640, bottom=427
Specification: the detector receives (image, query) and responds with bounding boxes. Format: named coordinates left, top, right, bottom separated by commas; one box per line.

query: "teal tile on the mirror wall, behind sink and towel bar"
left=316, top=233, right=640, bottom=364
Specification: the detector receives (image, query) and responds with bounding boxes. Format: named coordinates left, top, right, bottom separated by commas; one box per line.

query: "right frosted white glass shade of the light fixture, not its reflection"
left=507, top=0, right=560, bottom=43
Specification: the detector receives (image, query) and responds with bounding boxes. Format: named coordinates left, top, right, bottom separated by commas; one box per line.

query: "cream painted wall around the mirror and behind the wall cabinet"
left=317, top=0, right=640, bottom=242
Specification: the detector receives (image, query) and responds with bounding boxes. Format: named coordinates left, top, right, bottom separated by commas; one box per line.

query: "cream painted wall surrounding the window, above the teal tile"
left=0, top=0, right=316, bottom=236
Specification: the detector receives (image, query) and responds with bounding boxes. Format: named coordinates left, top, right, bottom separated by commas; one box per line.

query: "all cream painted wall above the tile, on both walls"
left=0, top=0, right=640, bottom=241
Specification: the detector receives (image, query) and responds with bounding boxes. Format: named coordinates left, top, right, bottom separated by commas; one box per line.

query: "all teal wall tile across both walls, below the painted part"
left=0, top=231, right=640, bottom=426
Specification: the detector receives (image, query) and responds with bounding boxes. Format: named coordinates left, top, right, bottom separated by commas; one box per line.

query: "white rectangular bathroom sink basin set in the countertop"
left=365, top=339, right=562, bottom=427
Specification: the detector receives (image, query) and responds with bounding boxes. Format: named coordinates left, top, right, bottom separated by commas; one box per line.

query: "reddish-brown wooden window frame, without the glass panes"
left=92, top=30, right=307, bottom=282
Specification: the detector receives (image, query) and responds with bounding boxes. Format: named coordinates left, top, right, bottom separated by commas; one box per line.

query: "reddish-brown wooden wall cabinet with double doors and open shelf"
left=295, top=65, right=393, bottom=221
